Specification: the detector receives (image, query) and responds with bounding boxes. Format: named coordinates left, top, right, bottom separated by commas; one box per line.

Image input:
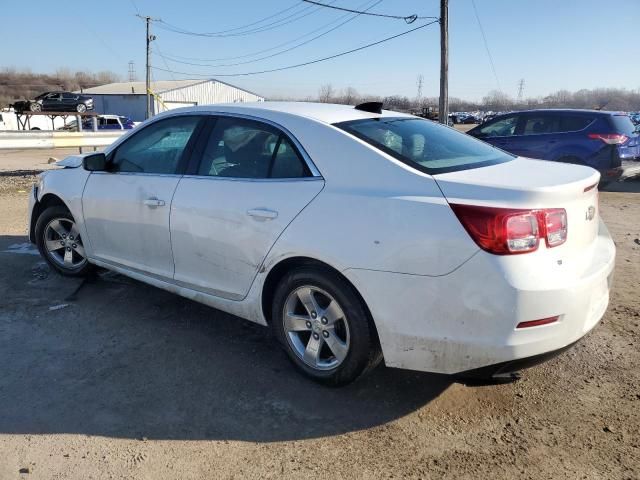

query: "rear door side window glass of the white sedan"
left=198, top=118, right=309, bottom=179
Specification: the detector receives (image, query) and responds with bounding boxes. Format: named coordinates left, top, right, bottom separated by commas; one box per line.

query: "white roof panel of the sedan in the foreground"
left=158, top=102, right=412, bottom=124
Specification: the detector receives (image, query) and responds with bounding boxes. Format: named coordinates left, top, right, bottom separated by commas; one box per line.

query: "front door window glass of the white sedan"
left=110, top=116, right=201, bottom=174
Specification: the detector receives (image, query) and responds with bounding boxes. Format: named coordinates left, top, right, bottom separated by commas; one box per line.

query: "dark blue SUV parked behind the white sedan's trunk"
left=467, top=110, right=640, bottom=183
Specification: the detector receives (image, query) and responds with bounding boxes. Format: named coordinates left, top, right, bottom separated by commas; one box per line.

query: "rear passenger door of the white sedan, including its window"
left=171, top=116, right=324, bottom=300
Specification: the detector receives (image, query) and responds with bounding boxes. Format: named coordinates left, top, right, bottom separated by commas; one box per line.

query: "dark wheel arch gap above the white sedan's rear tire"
left=261, top=256, right=380, bottom=345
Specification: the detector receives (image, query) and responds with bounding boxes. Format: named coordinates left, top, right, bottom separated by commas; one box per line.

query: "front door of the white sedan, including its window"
left=82, top=115, right=202, bottom=279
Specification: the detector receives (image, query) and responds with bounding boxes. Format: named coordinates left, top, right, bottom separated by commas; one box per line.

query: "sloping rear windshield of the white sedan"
left=335, top=117, right=514, bottom=175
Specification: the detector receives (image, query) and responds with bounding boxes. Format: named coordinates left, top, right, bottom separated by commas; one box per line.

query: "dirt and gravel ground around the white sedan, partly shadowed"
left=0, top=152, right=640, bottom=480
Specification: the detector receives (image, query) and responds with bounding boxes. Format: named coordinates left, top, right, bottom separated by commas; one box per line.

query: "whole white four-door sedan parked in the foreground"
left=29, top=103, right=615, bottom=385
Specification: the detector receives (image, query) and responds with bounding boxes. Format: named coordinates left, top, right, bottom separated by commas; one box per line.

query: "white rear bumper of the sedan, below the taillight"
left=344, top=218, right=615, bottom=374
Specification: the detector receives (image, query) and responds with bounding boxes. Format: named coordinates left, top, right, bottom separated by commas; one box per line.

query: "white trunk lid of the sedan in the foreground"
left=434, top=157, right=600, bottom=254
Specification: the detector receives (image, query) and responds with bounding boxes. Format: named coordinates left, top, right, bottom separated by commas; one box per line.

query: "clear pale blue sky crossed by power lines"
left=5, top=0, right=640, bottom=100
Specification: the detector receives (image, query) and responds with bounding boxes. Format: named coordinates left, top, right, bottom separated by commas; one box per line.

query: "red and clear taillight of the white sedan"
left=451, top=204, right=567, bottom=255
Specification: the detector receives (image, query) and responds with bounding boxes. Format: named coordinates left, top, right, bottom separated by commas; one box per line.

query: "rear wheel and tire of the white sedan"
left=271, top=266, right=382, bottom=387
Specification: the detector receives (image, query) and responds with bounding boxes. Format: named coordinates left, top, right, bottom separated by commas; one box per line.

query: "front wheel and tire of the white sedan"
left=35, top=206, right=93, bottom=277
